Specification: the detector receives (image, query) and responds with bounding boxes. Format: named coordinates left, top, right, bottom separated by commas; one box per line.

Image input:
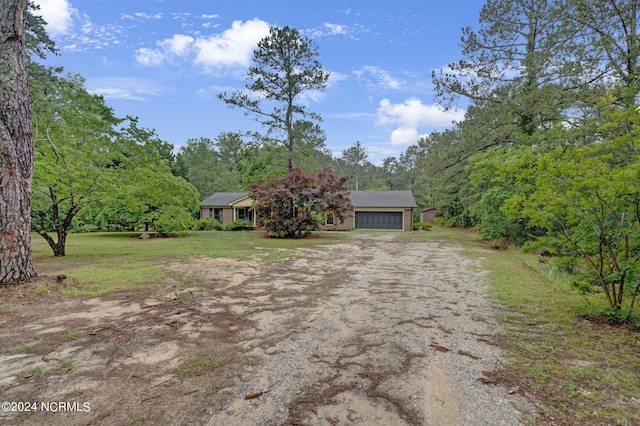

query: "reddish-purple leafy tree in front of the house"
left=249, top=168, right=353, bottom=238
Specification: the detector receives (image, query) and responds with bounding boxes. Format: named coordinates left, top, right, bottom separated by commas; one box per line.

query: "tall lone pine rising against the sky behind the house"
left=219, top=26, right=329, bottom=171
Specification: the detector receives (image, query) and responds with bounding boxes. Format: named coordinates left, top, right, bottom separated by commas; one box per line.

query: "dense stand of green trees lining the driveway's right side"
left=415, top=0, right=640, bottom=320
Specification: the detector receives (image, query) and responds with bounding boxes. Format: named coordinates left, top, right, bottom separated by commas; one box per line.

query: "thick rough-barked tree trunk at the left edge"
left=0, top=0, right=36, bottom=283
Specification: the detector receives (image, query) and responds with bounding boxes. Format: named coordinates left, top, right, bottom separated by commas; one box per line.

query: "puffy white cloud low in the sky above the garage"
left=376, top=98, right=464, bottom=145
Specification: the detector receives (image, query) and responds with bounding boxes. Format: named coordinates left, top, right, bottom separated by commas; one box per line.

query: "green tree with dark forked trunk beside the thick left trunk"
left=32, top=76, right=121, bottom=256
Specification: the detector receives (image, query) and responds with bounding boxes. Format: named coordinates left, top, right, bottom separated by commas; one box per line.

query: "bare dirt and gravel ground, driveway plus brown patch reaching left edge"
left=0, top=233, right=531, bottom=426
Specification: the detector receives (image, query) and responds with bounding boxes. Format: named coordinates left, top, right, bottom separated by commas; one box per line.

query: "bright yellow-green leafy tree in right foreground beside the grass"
left=503, top=143, right=640, bottom=319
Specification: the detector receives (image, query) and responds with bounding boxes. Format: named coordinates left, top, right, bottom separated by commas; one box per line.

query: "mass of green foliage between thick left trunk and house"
left=32, top=76, right=198, bottom=256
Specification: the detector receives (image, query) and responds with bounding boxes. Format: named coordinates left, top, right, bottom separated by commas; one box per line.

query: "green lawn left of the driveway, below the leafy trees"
left=31, top=231, right=348, bottom=296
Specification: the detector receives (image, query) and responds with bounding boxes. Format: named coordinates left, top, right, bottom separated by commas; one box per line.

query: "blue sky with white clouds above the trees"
left=28, top=0, right=484, bottom=164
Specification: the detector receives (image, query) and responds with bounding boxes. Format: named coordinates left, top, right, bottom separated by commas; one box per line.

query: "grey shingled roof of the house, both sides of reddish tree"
left=200, top=191, right=418, bottom=208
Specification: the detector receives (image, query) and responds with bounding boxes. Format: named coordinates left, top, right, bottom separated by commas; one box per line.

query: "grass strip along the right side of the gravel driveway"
left=420, top=228, right=640, bottom=425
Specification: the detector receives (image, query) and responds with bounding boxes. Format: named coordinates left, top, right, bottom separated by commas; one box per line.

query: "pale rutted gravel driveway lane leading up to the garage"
left=208, top=233, right=530, bottom=425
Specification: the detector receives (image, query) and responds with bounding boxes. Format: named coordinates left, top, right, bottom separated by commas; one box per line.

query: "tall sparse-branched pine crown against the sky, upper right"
left=433, top=0, right=572, bottom=130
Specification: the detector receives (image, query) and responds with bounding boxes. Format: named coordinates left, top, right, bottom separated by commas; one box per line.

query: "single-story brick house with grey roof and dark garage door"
left=200, top=191, right=418, bottom=231
